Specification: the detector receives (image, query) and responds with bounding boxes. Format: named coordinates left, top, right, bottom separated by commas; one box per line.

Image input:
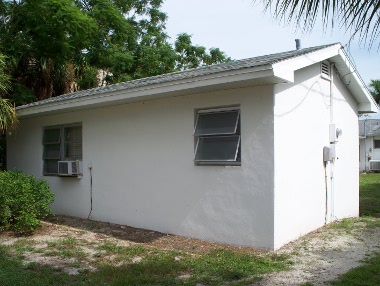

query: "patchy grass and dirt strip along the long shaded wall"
left=0, top=217, right=291, bottom=286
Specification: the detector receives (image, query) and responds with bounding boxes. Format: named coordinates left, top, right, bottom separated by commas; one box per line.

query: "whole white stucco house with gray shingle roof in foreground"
left=7, top=44, right=377, bottom=250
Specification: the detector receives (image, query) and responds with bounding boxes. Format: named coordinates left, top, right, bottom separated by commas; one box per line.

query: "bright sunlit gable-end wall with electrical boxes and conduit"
left=274, top=64, right=359, bottom=248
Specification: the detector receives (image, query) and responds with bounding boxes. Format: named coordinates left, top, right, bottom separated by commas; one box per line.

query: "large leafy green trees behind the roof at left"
left=0, top=0, right=228, bottom=104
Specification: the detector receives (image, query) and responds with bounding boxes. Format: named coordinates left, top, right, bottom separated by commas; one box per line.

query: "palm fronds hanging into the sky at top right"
left=254, top=0, right=380, bottom=46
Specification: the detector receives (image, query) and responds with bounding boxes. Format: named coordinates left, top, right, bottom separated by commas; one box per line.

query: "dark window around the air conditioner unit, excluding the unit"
left=43, top=124, right=82, bottom=175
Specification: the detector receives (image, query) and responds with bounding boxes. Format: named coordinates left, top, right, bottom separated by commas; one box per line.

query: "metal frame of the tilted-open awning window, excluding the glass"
left=193, top=106, right=241, bottom=166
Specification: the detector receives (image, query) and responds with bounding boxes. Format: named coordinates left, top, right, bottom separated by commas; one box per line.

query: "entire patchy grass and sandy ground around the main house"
left=0, top=174, right=380, bottom=286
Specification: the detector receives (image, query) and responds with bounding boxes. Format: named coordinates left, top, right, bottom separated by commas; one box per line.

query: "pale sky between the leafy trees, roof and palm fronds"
left=162, top=0, right=380, bottom=85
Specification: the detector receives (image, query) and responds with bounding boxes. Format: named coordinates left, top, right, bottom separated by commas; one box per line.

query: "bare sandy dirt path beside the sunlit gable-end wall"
left=255, top=223, right=380, bottom=286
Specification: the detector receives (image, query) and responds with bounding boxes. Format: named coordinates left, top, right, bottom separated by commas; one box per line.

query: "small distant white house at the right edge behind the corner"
left=359, top=119, right=380, bottom=172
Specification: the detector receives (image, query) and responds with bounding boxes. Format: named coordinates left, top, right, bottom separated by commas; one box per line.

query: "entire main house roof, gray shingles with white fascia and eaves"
left=17, top=44, right=376, bottom=117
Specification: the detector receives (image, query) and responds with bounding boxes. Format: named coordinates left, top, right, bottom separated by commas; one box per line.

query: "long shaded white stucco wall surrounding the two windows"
left=8, top=85, right=274, bottom=249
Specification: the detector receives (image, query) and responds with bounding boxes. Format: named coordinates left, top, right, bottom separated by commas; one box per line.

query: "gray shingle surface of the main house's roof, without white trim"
left=17, top=43, right=336, bottom=109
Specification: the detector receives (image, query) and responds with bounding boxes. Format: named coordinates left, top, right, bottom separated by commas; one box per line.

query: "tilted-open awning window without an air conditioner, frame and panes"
left=194, top=109, right=241, bottom=165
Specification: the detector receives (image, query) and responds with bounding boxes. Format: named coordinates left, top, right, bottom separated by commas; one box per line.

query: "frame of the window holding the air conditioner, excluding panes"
left=42, top=122, right=83, bottom=176
